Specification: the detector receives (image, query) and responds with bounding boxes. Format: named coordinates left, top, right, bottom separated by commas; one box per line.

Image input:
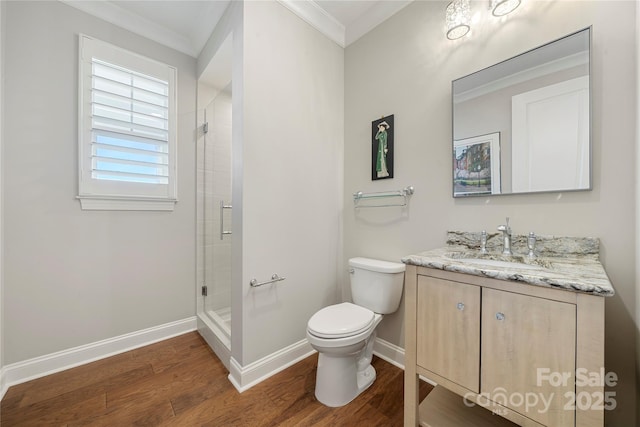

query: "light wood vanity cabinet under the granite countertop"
left=405, top=265, right=604, bottom=427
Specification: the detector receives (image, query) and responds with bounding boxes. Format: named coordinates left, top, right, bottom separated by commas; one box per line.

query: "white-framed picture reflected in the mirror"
left=453, top=132, right=500, bottom=197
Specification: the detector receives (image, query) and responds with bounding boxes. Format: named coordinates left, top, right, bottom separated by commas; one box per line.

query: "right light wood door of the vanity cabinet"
left=480, top=288, right=576, bottom=427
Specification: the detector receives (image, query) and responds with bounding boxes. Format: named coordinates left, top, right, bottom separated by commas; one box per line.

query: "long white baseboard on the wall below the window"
left=0, top=316, right=197, bottom=399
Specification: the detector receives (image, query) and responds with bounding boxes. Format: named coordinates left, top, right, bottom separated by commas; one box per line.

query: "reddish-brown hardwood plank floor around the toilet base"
left=0, top=332, right=431, bottom=427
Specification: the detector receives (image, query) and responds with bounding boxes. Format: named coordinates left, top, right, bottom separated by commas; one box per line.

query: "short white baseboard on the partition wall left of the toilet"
left=229, top=339, right=315, bottom=393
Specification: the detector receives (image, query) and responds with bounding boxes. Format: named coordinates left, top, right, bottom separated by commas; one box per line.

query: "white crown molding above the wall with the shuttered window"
left=60, top=0, right=200, bottom=58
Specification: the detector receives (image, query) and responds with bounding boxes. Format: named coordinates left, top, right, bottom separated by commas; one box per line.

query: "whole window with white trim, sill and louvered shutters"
left=78, top=34, right=177, bottom=210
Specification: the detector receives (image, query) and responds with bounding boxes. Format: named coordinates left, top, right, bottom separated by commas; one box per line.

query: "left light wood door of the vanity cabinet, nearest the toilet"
left=416, top=276, right=480, bottom=393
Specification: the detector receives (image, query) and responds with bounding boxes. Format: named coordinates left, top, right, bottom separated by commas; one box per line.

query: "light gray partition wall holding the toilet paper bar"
left=238, top=2, right=344, bottom=365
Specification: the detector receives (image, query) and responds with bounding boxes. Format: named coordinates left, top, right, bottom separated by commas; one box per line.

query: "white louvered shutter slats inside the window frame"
left=91, top=58, right=169, bottom=184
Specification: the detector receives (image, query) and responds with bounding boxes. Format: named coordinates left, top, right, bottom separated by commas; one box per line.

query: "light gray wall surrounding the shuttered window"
left=2, top=1, right=196, bottom=364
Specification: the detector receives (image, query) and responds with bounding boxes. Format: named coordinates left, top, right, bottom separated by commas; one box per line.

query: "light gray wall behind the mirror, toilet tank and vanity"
left=348, top=1, right=638, bottom=426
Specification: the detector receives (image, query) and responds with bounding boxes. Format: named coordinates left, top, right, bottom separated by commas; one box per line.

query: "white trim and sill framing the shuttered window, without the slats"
left=77, top=34, right=178, bottom=211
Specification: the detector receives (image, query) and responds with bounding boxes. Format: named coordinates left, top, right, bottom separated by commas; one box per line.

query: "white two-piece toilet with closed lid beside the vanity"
left=307, top=258, right=405, bottom=407
